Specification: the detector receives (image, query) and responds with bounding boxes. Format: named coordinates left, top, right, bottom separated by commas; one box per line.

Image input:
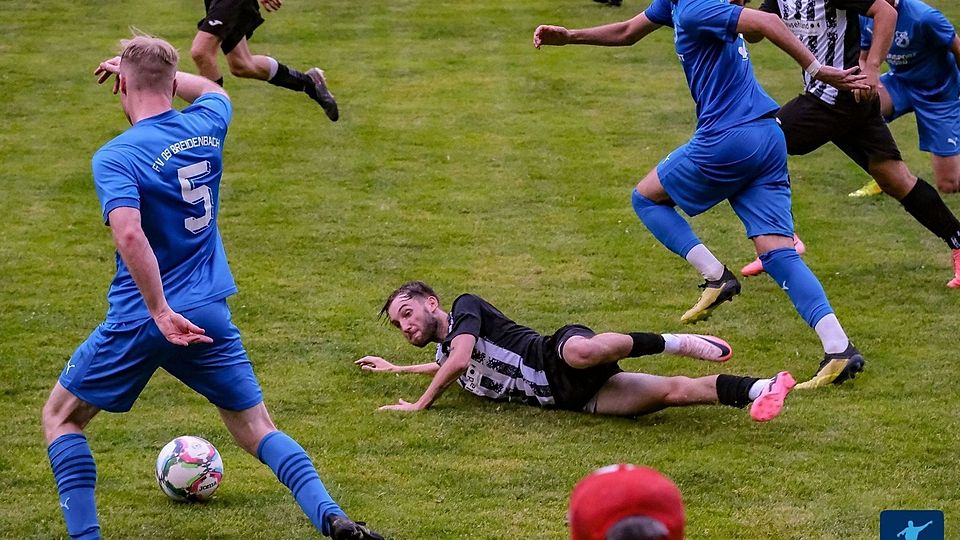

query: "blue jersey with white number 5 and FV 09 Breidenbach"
left=93, top=93, right=237, bottom=322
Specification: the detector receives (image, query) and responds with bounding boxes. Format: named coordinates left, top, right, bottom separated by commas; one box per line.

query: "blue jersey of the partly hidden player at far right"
left=860, top=0, right=960, bottom=99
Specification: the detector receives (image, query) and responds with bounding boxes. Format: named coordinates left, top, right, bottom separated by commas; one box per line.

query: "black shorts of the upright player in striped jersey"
left=777, top=92, right=902, bottom=171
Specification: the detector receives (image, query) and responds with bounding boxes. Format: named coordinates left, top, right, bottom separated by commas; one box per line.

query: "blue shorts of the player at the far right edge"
left=880, top=73, right=960, bottom=157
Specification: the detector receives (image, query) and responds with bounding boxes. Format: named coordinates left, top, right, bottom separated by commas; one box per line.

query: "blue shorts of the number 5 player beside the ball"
left=60, top=300, right=263, bottom=412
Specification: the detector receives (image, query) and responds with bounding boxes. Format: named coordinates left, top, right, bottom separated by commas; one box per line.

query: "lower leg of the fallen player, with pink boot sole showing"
left=584, top=371, right=796, bottom=422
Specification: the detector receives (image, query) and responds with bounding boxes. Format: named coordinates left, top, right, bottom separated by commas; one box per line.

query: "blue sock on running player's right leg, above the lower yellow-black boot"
left=760, top=248, right=833, bottom=328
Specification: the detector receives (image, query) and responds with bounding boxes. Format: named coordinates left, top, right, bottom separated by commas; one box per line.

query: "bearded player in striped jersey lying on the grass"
left=356, top=281, right=795, bottom=422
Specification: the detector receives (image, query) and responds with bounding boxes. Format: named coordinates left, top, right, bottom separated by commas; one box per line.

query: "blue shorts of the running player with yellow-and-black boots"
left=657, top=118, right=793, bottom=238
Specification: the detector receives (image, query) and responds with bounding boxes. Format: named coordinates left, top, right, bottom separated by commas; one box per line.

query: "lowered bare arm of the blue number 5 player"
left=107, top=207, right=213, bottom=346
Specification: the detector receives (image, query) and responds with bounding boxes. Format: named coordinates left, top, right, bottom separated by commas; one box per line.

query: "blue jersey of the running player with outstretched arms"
left=645, top=0, right=778, bottom=135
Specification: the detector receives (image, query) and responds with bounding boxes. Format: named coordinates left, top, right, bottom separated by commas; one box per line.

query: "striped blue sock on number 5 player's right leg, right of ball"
left=257, top=431, right=346, bottom=536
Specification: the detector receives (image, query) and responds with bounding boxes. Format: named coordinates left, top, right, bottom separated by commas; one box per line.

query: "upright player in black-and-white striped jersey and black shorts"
left=735, top=0, right=960, bottom=288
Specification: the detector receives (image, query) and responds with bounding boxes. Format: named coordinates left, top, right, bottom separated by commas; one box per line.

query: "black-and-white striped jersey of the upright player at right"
left=760, top=0, right=874, bottom=105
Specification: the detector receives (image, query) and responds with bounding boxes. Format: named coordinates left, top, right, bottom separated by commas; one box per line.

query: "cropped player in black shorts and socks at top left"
left=190, top=0, right=340, bottom=122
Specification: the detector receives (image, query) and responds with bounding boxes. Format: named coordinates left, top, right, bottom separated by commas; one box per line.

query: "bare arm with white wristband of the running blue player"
left=737, top=8, right=883, bottom=90
